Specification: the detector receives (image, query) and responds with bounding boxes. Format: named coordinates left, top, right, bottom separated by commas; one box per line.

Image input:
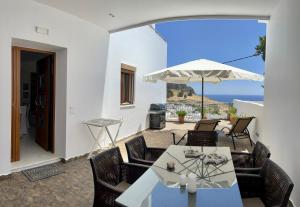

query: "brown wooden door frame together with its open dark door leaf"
left=11, top=46, right=55, bottom=162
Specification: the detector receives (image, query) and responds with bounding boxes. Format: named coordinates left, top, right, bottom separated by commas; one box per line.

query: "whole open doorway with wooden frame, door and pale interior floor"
left=11, top=47, right=55, bottom=167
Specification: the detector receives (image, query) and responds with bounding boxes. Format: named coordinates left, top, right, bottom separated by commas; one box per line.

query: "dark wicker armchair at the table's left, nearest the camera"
left=90, top=147, right=149, bottom=207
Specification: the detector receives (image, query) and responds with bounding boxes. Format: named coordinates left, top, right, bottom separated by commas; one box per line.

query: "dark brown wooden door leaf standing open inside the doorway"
left=35, top=56, right=52, bottom=150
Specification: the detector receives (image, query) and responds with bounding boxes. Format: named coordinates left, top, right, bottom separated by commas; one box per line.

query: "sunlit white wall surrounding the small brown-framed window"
left=103, top=26, right=167, bottom=141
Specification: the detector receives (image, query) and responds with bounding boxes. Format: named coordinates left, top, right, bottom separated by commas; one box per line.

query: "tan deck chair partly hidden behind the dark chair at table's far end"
left=172, top=119, right=220, bottom=145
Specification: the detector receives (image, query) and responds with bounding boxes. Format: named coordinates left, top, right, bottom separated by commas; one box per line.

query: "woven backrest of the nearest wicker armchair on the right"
left=261, top=159, right=294, bottom=207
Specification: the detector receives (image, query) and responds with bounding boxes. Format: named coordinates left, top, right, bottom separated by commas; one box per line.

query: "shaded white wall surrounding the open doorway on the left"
left=0, top=0, right=109, bottom=175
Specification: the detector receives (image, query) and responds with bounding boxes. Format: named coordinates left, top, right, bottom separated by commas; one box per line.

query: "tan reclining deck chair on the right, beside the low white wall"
left=222, top=117, right=255, bottom=149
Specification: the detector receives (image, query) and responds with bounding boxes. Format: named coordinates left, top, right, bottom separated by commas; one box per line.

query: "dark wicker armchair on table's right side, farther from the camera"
left=231, top=141, right=271, bottom=173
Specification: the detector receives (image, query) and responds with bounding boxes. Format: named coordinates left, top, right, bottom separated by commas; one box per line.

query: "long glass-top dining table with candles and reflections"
left=116, top=145, right=243, bottom=207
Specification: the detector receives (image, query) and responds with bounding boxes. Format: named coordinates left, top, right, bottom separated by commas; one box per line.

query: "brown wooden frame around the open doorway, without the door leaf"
left=11, top=46, right=56, bottom=162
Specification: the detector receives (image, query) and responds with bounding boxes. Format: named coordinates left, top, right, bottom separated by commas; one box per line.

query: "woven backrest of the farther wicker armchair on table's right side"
left=252, top=141, right=271, bottom=167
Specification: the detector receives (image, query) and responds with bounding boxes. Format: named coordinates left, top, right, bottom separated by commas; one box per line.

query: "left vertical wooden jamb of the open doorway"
left=11, top=47, right=21, bottom=162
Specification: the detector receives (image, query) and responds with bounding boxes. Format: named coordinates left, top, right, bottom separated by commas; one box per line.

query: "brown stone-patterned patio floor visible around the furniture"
left=0, top=123, right=251, bottom=207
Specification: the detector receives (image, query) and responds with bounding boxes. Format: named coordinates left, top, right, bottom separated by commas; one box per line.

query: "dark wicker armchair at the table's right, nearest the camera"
left=237, top=159, right=294, bottom=207
